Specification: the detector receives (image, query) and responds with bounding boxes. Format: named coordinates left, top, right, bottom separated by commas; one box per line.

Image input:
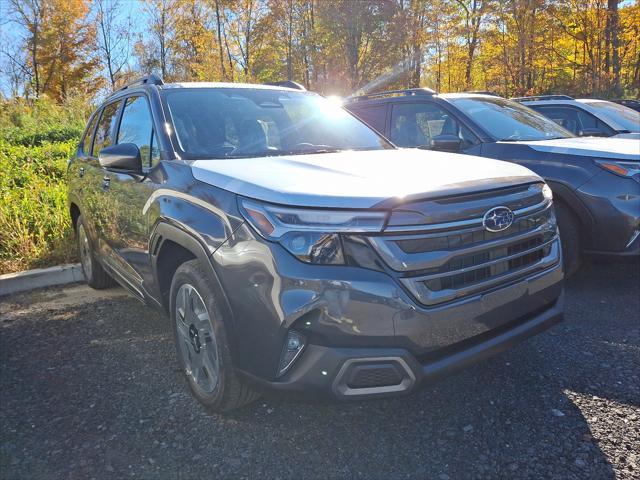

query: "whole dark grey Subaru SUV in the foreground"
left=68, top=76, right=563, bottom=411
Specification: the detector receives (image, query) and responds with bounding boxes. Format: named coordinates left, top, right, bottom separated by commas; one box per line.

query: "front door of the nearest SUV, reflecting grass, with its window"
left=104, top=94, right=159, bottom=296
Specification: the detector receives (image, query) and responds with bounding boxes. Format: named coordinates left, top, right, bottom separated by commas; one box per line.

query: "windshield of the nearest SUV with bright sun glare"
left=164, top=88, right=393, bottom=159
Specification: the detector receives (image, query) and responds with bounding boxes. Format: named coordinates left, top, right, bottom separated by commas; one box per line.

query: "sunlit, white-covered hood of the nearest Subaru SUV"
left=190, top=149, right=541, bottom=208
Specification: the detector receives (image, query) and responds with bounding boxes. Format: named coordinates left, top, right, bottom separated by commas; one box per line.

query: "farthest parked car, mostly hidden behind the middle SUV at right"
left=512, top=95, right=640, bottom=139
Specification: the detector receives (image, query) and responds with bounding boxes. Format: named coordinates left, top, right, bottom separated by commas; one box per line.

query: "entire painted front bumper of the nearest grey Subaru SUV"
left=213, top=225, right=563, bottom=397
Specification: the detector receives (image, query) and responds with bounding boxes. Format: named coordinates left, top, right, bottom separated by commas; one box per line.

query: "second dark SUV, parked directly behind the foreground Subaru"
left=345, top=89, right=640, bottom=274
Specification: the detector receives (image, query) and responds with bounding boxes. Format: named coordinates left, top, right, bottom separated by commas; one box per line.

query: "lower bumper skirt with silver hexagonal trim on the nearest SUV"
left=242, top=295, right=564, bottom=399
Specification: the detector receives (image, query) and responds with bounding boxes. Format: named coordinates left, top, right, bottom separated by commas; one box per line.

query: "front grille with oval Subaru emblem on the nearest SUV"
left=369, top=185, right=560, bottom=306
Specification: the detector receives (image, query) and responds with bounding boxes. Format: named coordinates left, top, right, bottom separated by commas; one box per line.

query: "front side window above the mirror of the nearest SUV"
left=117, top=97, right=157, bottom=167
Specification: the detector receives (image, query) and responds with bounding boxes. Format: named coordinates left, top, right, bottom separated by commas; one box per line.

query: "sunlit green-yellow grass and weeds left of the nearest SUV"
left=0, top=98, right=91, bottom=273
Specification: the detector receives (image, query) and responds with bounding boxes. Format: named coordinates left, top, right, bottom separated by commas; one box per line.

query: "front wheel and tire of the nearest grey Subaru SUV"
left=170, top=260, right=259, bottom=413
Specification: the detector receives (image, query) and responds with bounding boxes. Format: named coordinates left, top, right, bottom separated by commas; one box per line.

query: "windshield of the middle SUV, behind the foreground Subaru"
left=446, top=96, right=573, bottom=141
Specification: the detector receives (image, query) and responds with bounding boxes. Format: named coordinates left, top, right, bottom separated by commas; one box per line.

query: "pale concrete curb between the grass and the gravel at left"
left=0, top=263, right=84, bottom=296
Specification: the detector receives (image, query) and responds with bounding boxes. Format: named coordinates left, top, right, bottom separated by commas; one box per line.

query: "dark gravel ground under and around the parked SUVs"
left=0, top=264, right=640, bottom=480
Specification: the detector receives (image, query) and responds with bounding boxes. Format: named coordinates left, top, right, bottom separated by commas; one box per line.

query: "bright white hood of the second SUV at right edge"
left=510, top=137, right=640, bottom=161
